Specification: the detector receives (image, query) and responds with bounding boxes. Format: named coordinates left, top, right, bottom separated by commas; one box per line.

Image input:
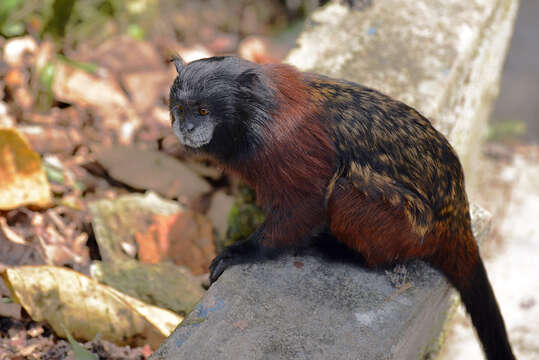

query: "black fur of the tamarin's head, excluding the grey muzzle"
left=170, top=57, right=275, bottom=162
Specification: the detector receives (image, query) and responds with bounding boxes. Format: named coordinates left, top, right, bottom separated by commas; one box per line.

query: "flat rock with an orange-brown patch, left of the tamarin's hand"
left=89, top=192, right=215, bottom=275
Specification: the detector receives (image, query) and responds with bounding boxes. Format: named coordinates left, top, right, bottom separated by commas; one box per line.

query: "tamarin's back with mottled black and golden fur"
left=307, top=75, right=469, bottom=223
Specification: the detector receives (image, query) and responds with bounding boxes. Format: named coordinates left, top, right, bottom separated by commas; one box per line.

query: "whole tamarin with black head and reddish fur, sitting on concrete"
left=170, top=57, right=514, bottom=360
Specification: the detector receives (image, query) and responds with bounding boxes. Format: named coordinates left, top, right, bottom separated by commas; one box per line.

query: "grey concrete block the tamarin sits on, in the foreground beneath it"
left=151, top=208, right=490, bottom=360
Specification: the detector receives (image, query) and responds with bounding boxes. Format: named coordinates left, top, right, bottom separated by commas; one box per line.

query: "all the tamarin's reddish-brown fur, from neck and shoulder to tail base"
left=235, top=65, right=478, bottom=282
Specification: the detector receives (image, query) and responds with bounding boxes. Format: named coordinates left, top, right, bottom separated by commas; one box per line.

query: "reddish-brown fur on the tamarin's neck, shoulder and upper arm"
left=228, top=65, right=336, bottom=246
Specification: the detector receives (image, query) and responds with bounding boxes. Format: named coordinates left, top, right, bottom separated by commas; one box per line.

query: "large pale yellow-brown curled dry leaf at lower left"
left=0, top=266, right=183, bottom=348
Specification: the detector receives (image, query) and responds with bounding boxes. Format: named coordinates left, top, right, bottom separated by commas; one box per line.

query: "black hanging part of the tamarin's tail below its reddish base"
left=433, top=237, right=515, bottom=360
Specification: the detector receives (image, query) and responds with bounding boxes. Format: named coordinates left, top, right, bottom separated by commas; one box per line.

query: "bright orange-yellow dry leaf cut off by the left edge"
left=0, top=128, right=51, bottom=210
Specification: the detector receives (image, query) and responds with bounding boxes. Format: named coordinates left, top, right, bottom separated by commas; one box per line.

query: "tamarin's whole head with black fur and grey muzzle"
left=169, top=56, right=275, bottom=160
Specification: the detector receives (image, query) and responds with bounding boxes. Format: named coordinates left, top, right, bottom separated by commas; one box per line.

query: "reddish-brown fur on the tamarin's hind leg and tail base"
left=328, top=181, right=479, bottom=286
